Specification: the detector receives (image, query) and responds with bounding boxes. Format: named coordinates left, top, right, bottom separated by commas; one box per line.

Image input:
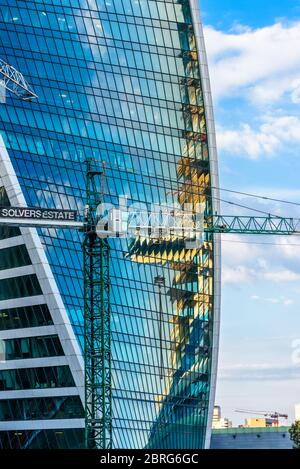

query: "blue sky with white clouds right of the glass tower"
left=200, top=0, right=300, bottom=425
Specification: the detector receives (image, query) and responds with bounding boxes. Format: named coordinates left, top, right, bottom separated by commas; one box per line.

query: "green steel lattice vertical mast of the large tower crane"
left=83, top=161, right=112, bottom=449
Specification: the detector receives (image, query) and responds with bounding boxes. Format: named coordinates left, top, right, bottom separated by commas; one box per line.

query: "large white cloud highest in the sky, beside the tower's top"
left=205, top=22, right=300, bottom=103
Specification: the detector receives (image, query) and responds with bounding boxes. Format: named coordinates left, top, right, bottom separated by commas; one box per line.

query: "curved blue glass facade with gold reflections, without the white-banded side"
left=0, top=0, right=219, bottom=448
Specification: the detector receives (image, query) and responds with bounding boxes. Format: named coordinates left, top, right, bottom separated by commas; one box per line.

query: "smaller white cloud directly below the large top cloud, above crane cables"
left=217, top=115, right=300, bottom=160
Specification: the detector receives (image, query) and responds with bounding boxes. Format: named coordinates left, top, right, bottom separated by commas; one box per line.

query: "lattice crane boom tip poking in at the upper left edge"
left=0, top=59, right=38, bottom=101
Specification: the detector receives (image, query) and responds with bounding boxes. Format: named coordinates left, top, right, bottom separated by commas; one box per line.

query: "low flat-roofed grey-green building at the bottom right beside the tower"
left=210, top=427, right=293, bottom=449
